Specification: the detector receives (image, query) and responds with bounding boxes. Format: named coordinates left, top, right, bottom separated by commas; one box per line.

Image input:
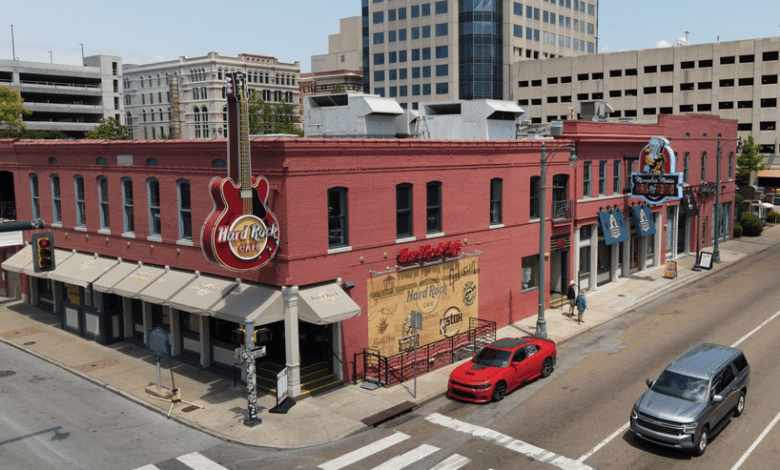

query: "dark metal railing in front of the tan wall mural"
left=352, top=318, right=496, bottom=386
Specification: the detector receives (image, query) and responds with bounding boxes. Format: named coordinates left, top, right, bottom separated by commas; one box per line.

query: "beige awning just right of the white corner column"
left=298, top=282, right=360, bottom=325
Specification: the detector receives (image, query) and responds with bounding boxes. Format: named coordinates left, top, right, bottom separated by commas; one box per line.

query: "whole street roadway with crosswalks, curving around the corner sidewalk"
left=0, top=247, right=780, bottom=470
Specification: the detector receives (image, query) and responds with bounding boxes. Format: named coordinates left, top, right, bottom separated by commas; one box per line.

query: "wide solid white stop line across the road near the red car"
left=425, top=413, right=593, bottom=470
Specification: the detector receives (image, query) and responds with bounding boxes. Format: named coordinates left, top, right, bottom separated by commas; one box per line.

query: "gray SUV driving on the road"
left=631, top=343, right=750, bottom=455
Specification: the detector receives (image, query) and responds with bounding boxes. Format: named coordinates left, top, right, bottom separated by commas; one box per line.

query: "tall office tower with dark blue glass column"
left=362, top=0, right=598, bottom=109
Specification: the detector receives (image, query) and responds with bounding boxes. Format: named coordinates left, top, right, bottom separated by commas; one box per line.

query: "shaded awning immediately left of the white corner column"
left=206, top=282, right=284, bottom=326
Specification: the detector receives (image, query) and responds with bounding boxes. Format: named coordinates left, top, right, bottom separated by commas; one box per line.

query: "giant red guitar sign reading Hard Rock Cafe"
left=200, top=72, right=279, bottom=271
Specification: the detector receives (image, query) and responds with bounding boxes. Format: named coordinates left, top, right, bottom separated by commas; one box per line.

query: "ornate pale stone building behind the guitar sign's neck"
left=123, top=52, right=301, bottom=140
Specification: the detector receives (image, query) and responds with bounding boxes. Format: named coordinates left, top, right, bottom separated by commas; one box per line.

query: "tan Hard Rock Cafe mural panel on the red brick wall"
left=367, top=257, right=479, bottom=356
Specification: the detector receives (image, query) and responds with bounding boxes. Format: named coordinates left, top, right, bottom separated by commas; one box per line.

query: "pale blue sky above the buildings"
left=0, top=0, right=780, bottom=73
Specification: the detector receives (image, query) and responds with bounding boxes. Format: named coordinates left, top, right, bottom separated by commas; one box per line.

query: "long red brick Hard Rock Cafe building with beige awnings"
left=0, top=115, right=737, bottom=396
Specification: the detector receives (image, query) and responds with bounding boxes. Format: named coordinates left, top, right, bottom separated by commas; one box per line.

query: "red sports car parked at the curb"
left=447, top=337, right=557, bottom=403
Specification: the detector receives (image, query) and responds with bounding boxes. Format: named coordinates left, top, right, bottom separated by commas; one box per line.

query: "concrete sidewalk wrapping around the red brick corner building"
left=0, top=226, right=780, bottom=448
